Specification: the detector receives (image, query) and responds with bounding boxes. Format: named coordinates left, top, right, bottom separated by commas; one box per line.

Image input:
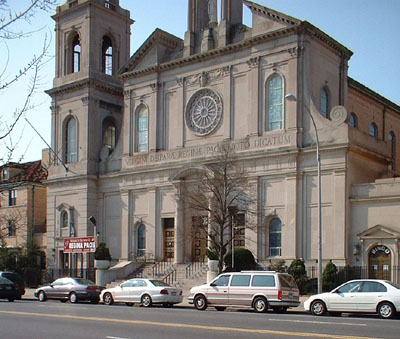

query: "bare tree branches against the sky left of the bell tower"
left=0, top=0, right=58, bottom=163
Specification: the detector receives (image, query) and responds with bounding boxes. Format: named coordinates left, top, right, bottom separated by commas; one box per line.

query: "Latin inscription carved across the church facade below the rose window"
left=126, top=134, right=293, bottom=167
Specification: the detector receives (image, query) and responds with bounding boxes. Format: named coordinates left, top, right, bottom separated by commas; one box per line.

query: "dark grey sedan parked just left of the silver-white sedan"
left=34, top=278, right=104, bottom=304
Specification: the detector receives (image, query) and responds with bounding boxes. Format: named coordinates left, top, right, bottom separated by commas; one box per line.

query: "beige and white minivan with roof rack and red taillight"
left=188, top=271, right=300, bottom=312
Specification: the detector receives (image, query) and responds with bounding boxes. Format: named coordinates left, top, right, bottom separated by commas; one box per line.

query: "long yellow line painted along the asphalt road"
left=0, top=311, right=379, bottom=339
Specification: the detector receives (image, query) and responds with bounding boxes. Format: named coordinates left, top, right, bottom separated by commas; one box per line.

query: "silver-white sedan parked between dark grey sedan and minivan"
left=100, top=279, right=183, bottom=307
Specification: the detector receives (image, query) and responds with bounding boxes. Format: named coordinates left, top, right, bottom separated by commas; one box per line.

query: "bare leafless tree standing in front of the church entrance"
left=183, top=143, right=255, bottom=272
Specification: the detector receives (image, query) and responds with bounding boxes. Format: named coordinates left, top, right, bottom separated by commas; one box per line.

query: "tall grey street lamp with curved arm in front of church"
left=285, top=94, right=322, bottom=293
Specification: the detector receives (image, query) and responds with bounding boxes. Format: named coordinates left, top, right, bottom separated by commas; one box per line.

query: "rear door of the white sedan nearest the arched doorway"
left=357, top=281, right=387, bottom=312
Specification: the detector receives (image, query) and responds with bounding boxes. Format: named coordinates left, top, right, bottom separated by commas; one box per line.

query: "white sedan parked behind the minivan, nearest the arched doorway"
left=304, top=279, right=400, bottom=319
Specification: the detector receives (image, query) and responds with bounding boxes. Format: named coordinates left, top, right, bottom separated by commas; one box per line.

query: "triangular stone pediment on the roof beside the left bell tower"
left=119, top=28, right=183, bottom=74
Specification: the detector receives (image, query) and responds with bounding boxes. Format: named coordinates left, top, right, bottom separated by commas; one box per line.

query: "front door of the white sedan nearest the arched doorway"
left=327, top=281, right=362, bottom=312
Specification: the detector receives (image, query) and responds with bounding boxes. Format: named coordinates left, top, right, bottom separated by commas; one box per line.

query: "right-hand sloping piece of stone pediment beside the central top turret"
left=243, top=0, right=301, bottom=33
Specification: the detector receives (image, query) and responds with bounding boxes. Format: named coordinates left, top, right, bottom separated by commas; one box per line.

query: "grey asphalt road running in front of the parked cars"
left=0, top=300, right=400, bottom=339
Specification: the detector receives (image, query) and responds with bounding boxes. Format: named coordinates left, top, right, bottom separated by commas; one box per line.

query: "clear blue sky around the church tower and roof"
left=0, top=0, right=400, bottom=163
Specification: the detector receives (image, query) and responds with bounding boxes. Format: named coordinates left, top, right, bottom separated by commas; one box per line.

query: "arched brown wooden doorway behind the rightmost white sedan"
left=368, top=245, right=392, bottom=280
